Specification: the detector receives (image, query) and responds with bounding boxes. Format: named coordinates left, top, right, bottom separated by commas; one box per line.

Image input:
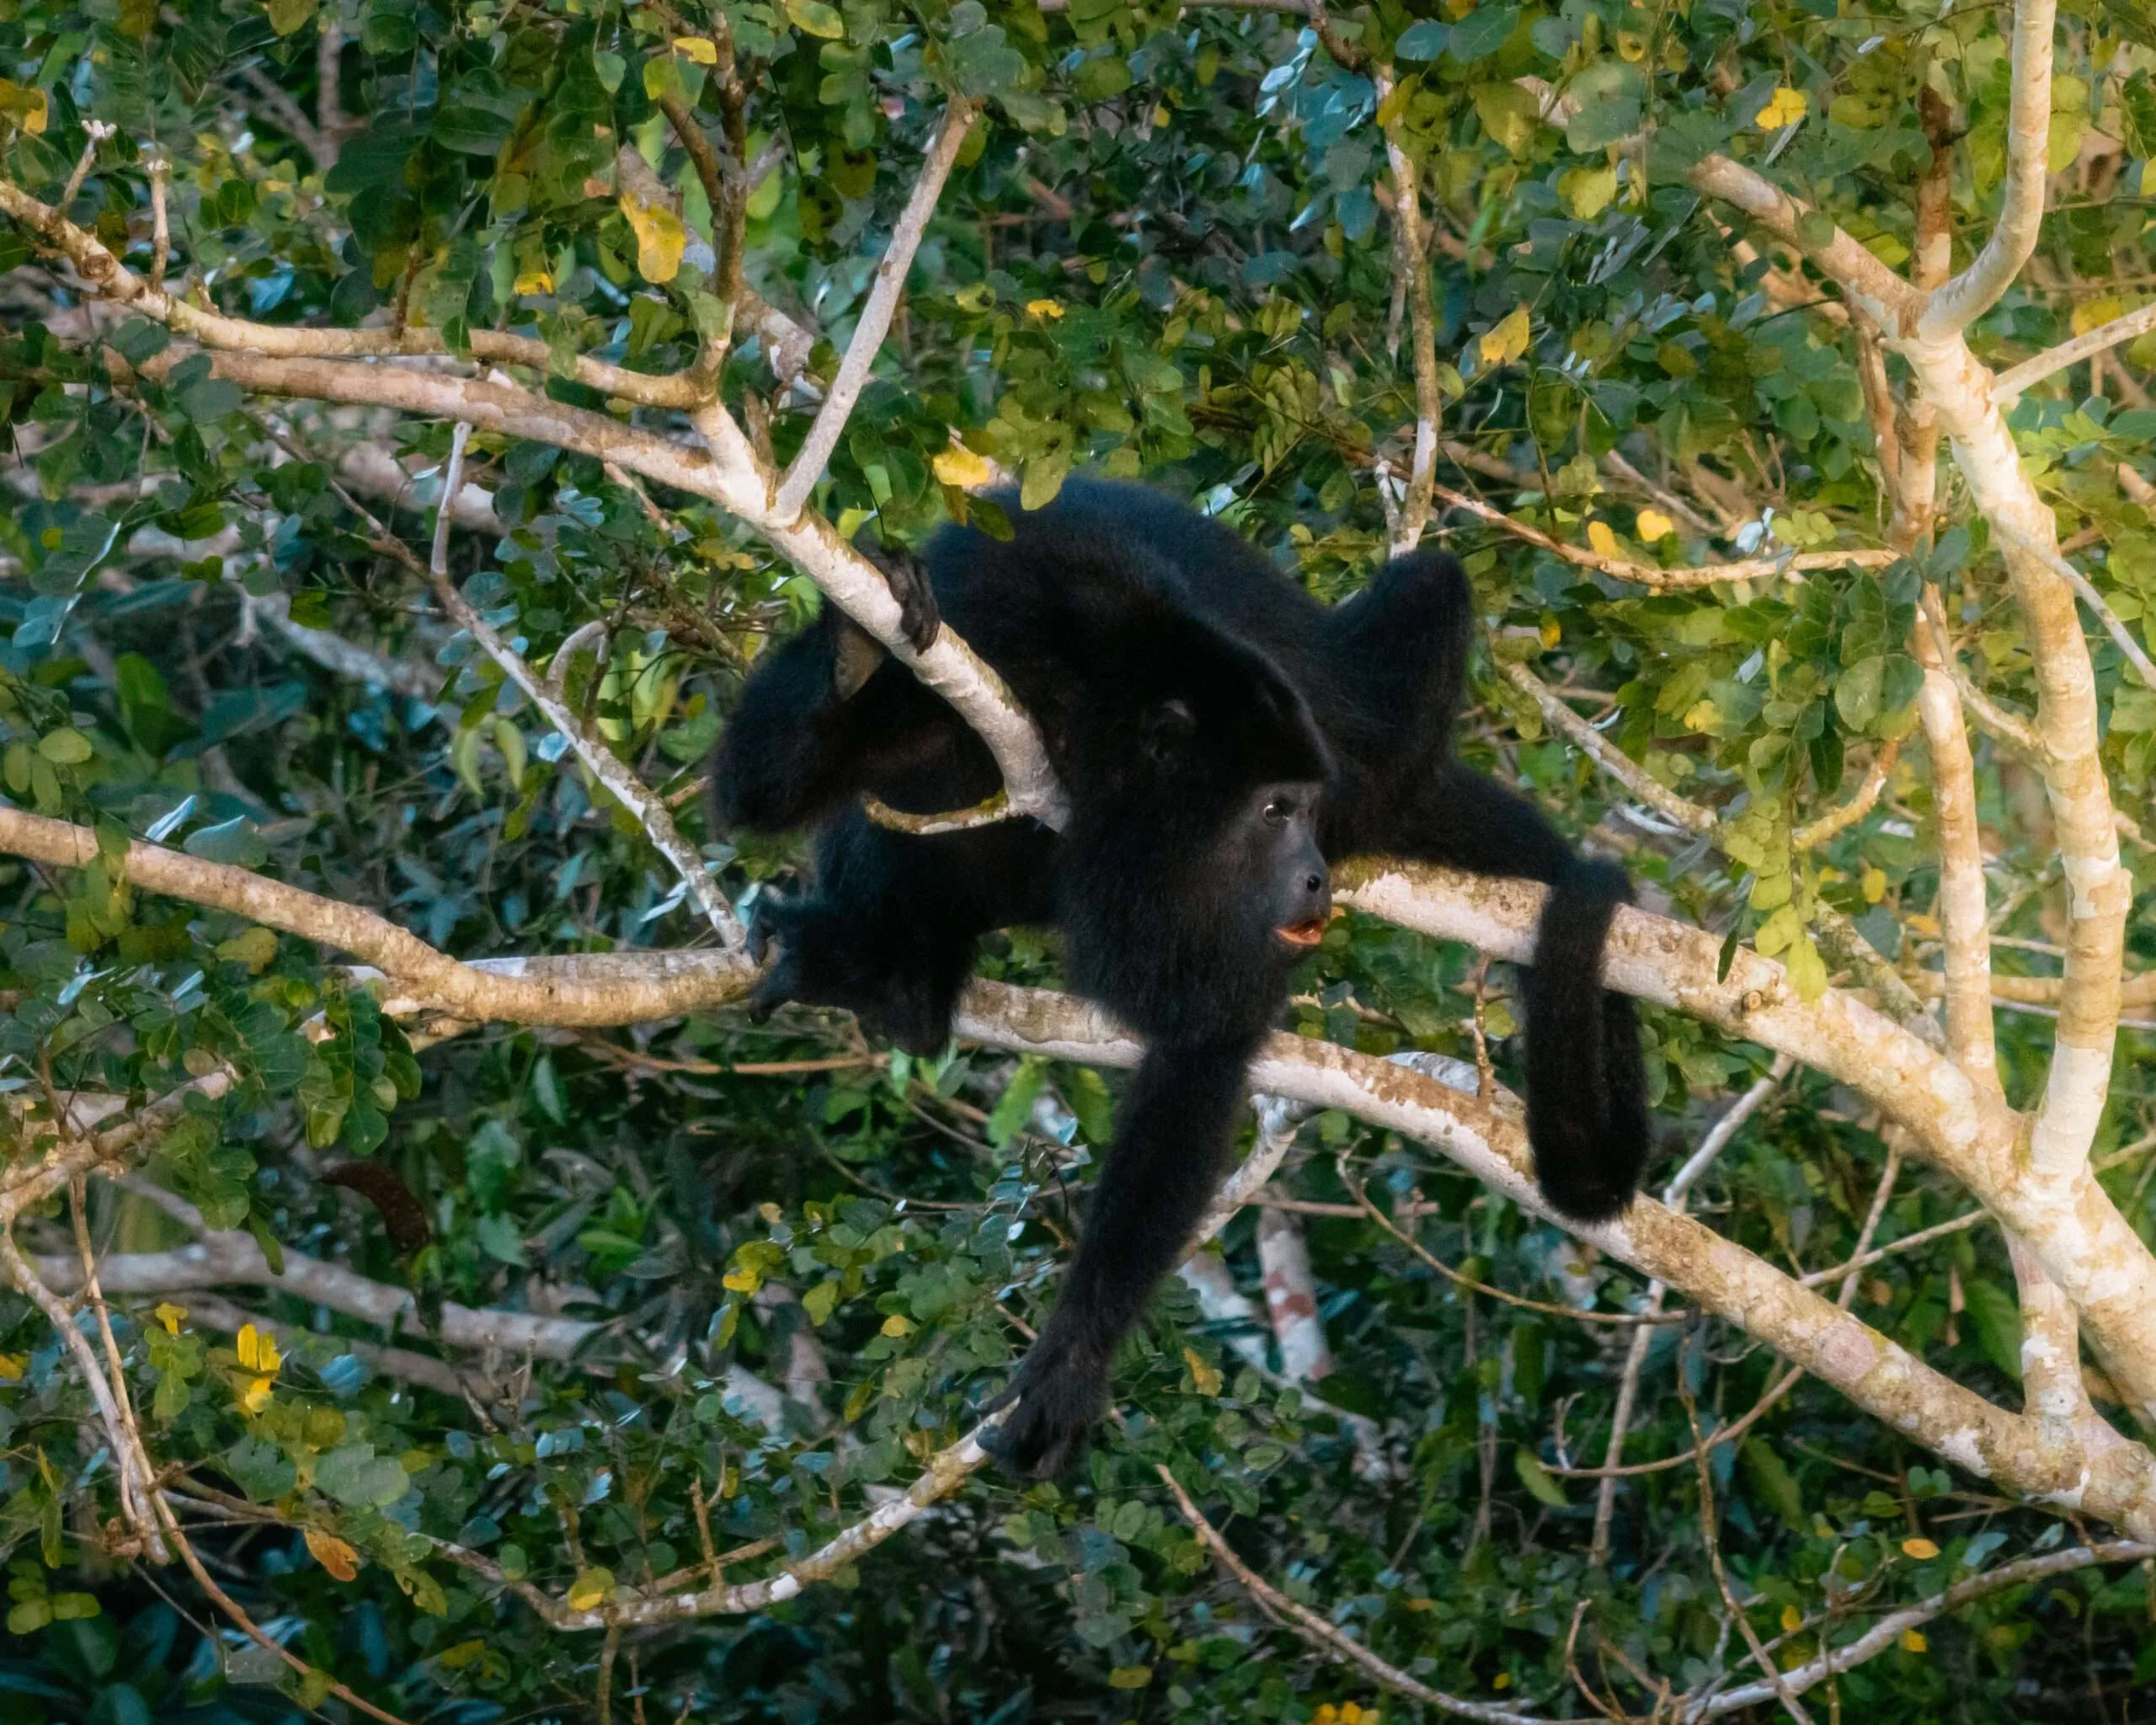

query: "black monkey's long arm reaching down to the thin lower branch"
left=994, top=1039, right=1257, bottom=1477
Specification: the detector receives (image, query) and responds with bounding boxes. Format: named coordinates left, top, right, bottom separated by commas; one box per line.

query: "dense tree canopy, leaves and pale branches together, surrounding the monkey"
left=0, top=0, right=2156, bottom=1725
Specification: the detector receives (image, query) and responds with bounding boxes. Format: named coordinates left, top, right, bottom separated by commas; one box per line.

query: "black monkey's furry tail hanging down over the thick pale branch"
left=1524, top=858, right=1652, bottom=1223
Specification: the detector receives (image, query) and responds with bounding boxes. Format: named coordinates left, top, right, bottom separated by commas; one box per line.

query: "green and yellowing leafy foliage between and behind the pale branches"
left=0, top=0, right=2156, bottom=1725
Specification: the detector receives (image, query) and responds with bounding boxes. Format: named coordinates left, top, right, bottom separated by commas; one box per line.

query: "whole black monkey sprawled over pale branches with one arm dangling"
left=713, top=478, right=1649, bottom=1472
